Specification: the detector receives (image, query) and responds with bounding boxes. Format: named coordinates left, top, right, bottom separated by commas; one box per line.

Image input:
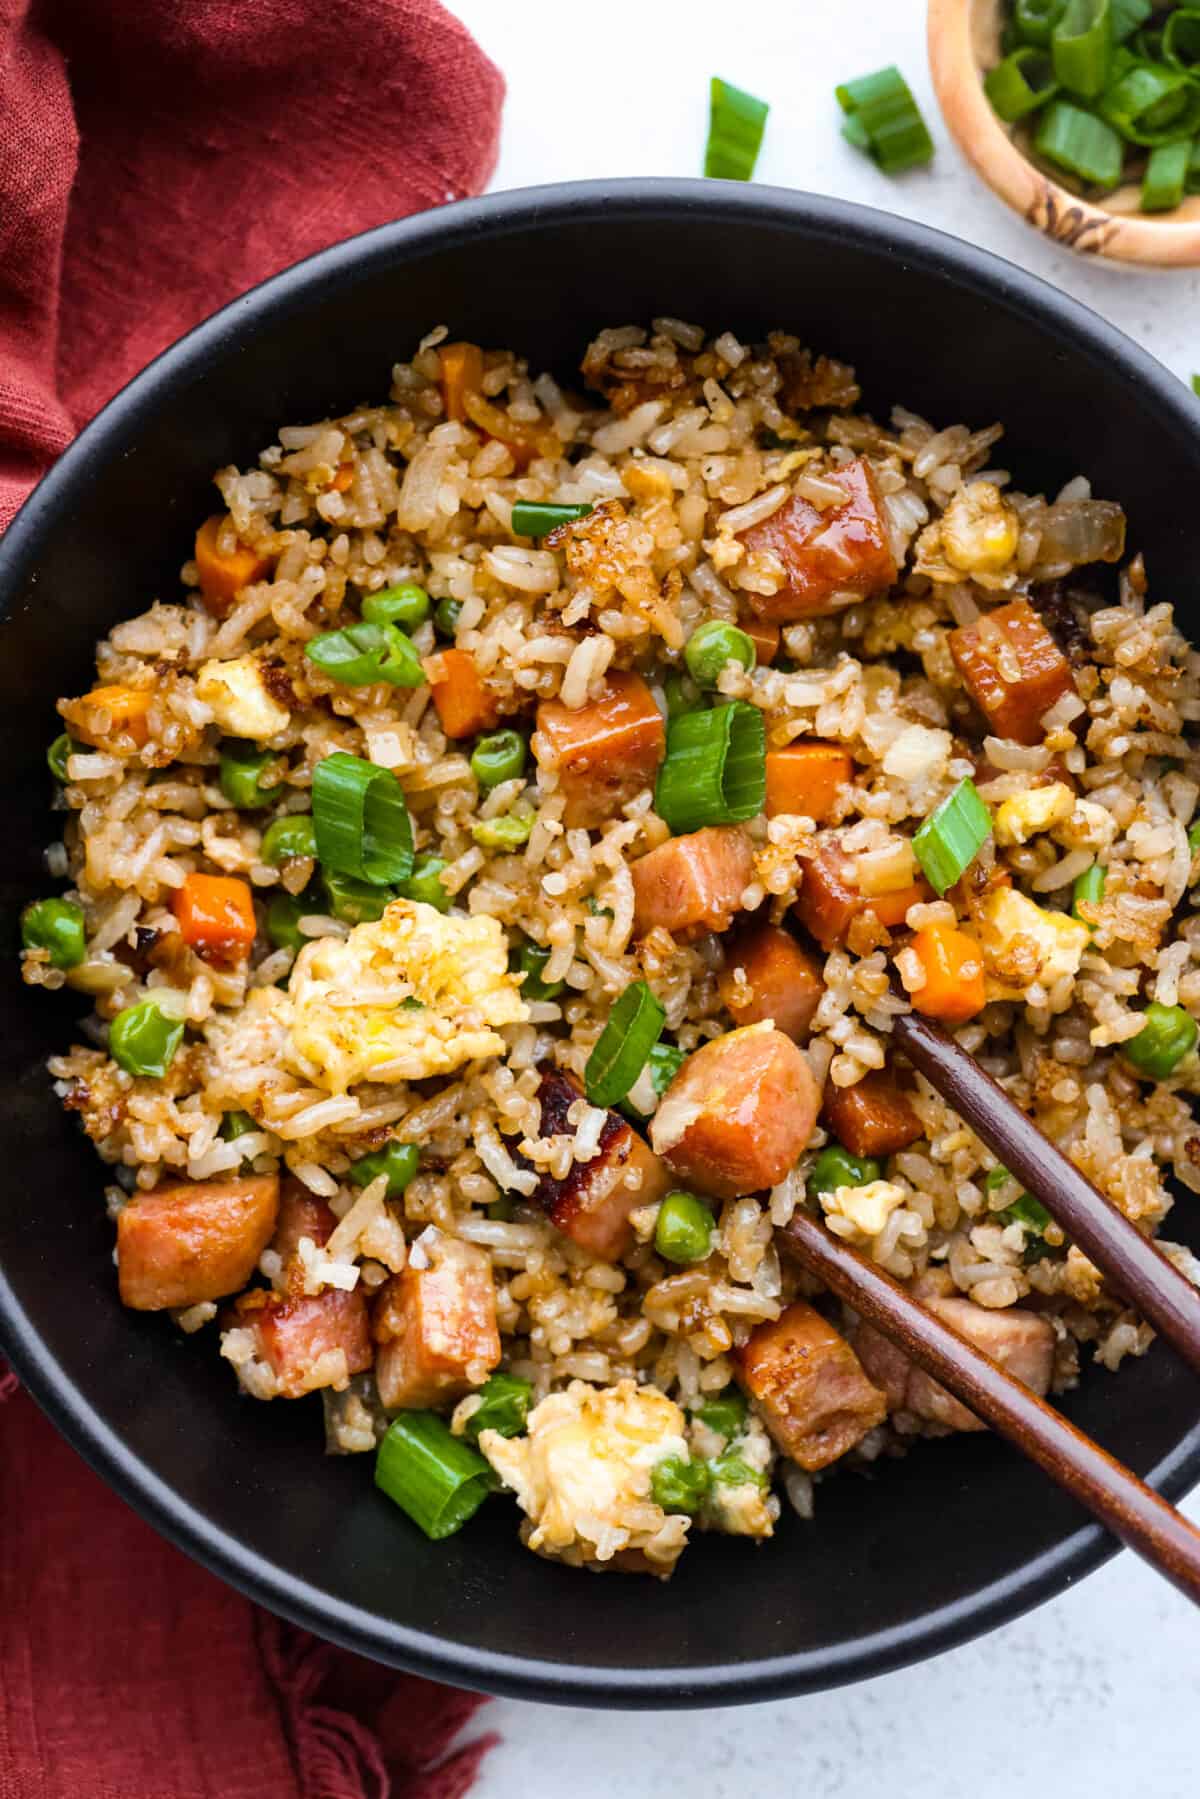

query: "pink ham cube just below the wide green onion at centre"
left=631, top=824, right=754, bottom=941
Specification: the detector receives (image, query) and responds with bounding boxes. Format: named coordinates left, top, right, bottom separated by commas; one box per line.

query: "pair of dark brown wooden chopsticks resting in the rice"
left=783, top=1013, right=1200, bottom=1603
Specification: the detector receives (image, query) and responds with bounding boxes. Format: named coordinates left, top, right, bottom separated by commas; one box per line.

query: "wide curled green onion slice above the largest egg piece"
left=313, top=750, right=412, bottom=887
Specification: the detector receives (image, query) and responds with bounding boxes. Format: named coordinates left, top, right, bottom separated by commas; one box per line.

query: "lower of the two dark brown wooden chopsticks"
left=779, top=1213, right=1200, bottom=1603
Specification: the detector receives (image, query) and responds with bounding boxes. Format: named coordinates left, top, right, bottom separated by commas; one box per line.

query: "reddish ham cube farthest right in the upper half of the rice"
left=948, top=599, right=1076, bottom=743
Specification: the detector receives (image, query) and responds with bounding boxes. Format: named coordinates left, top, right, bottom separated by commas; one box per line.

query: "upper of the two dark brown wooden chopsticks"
left=892, top=1013, right=1200, bottom=1369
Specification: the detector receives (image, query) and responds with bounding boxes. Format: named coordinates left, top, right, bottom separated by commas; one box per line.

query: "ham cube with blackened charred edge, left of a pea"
left=534, top=1070, right=671, bottom=1261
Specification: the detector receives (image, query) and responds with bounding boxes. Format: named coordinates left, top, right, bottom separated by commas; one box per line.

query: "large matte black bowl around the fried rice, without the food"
left=0, top=182, right=1200, bottom=1705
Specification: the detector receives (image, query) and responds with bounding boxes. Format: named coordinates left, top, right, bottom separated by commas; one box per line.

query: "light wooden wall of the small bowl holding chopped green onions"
left=928, top=0, right=1200, bottom=268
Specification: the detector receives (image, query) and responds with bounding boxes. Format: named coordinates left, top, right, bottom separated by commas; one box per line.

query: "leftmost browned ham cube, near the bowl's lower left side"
left=117, top=1175, right=279, bottom=1311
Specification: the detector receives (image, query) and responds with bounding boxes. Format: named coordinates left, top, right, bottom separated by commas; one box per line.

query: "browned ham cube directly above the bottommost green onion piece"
left=372, top=1238, right=500, bottom=1410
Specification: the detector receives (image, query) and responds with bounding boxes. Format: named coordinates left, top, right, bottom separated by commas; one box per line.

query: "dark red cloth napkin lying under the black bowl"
left=0, top=0, right=504, bottom=1799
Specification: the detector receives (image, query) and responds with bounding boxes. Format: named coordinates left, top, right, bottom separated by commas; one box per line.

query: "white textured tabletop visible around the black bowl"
left=452, top=0, right=1200, bottom=1770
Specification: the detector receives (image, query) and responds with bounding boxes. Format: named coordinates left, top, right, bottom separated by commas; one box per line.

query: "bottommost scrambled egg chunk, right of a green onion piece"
left=479, top=1380, right=691, bottom=1578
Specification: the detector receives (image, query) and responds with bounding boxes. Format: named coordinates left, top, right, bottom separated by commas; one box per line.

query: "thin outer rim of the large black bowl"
left=0, top=178, right=1200, bottom=1707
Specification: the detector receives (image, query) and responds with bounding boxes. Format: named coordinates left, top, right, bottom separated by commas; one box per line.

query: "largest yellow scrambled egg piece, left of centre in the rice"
left=288, top=900, right=529, bottom=1094
